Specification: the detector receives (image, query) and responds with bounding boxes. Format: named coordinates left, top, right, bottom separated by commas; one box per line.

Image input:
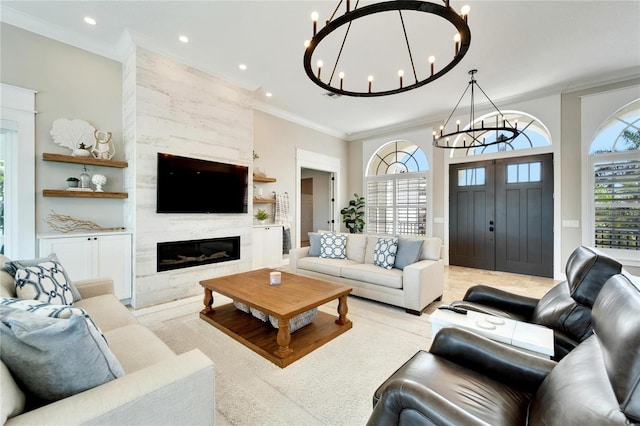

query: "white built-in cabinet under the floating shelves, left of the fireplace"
left=38, top=232, right=132, bottom=300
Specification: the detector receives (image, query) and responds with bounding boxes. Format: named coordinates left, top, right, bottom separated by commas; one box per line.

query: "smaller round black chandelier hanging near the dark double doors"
left=433, top=70, right=522, bottom=149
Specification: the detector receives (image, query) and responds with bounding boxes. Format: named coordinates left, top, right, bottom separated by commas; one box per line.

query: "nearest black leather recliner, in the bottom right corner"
left=367, top=274, right=640, bottom=426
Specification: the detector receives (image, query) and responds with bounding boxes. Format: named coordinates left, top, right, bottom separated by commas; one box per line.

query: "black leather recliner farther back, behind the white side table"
left=451, top=246, right=622, bottom=360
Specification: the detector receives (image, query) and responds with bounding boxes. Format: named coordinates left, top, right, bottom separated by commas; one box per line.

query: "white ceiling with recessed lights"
left=0, top=0, right=640, bottom=139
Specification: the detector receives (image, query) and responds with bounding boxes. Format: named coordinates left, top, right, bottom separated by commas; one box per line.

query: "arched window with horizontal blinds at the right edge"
left=589, top=99, right=640, bottom=250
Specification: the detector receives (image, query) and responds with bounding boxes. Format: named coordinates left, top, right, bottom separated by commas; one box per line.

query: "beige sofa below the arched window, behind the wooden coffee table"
left=289, top=231, right=444, bottom=315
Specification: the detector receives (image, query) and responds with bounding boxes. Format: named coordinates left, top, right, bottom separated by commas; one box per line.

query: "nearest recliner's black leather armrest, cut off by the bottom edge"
left=367, top=379, right=486, bottom=426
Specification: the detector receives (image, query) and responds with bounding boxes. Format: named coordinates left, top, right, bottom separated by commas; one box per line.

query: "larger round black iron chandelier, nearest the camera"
left=304, top=0, right=471, bottom=97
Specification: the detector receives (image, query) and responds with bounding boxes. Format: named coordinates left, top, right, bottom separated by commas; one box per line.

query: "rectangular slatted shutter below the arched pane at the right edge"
left=594, top=153, right=640, bottom=250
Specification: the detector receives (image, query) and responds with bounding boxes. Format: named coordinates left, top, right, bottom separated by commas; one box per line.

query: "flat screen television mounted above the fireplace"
left=156, top=152, right=249, bottom=213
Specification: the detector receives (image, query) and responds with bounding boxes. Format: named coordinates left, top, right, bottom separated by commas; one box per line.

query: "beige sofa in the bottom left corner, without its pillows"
left=0, top=255, right=215, bottom=426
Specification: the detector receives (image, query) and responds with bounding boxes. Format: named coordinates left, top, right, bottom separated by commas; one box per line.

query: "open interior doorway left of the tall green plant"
left=300, top=168, right=335, bottom=247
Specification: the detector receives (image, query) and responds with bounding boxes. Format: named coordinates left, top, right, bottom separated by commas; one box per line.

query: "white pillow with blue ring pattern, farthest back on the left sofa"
left=15, top=260, right=73, bottom=305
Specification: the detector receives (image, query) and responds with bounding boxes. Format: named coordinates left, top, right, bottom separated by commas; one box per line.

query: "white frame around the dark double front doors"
left=443, top=144, right=566, bottom=280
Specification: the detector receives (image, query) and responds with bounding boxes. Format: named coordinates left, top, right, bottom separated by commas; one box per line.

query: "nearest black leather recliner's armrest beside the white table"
left=429, top=328, right=557, bottom=392
